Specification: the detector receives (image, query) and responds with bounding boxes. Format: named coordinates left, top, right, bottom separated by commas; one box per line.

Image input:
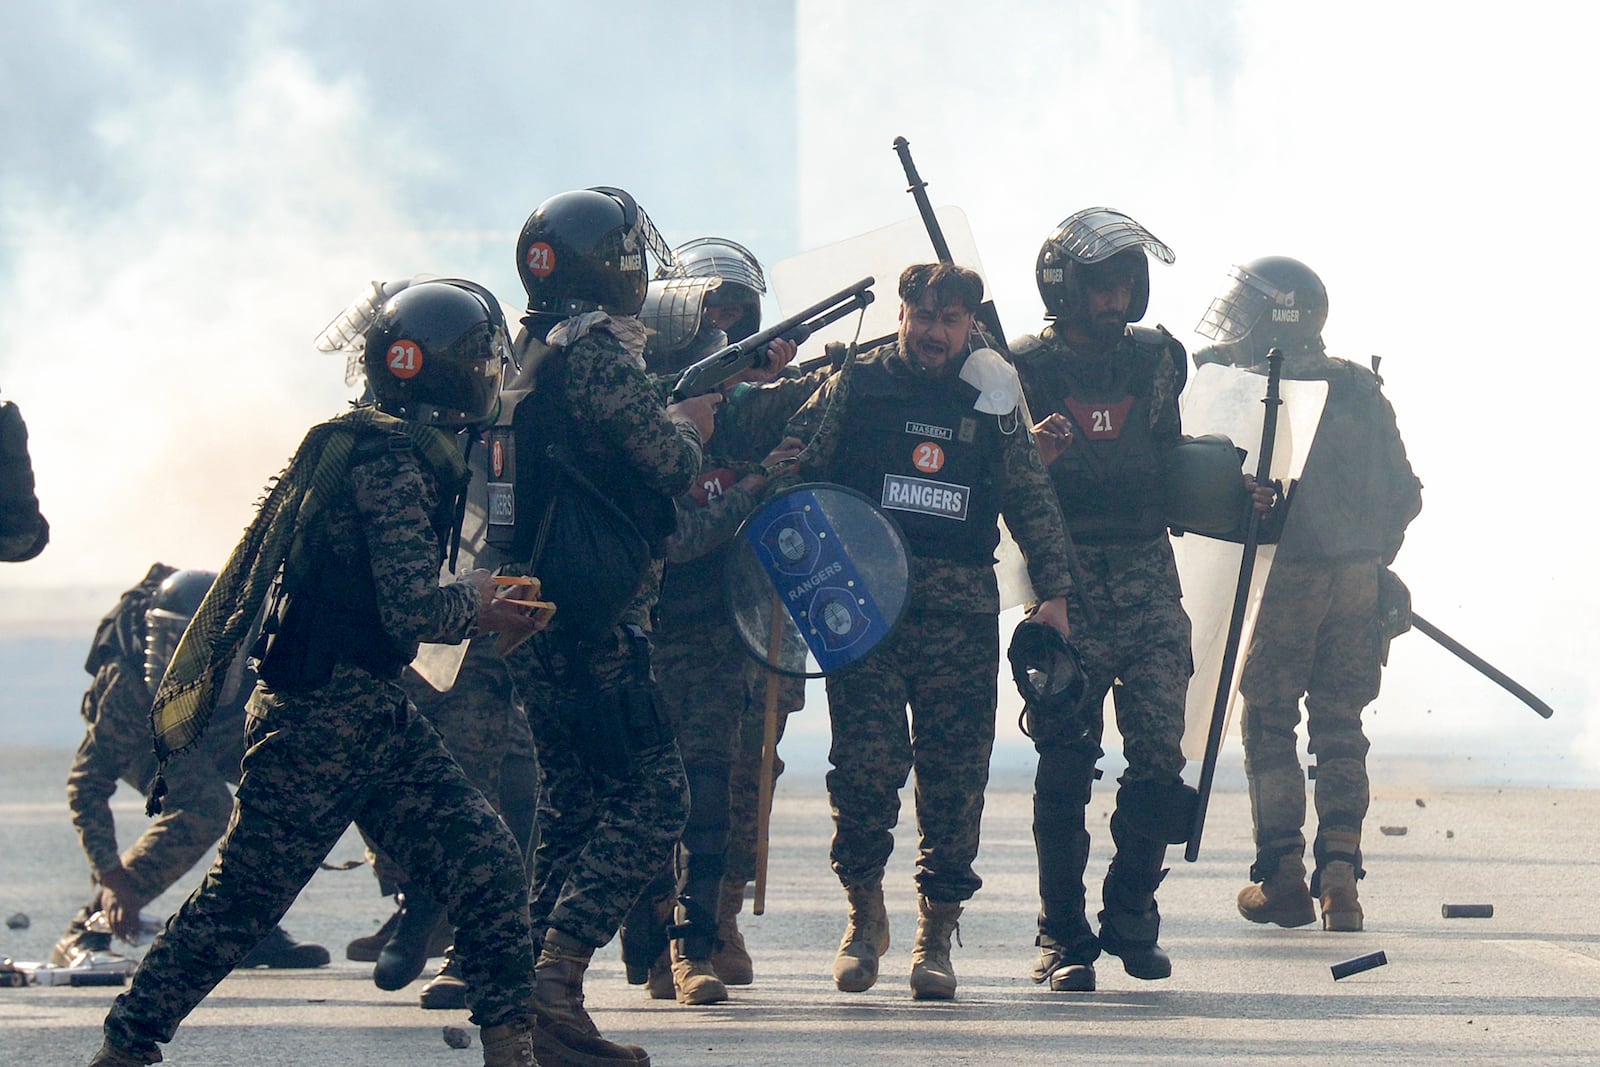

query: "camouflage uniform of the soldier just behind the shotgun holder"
left=622, top=371, right=826, bottom=982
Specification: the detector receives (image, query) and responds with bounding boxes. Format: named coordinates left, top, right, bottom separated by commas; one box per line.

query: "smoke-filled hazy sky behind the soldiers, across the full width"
left=0, top=0, right=1600, bottom=774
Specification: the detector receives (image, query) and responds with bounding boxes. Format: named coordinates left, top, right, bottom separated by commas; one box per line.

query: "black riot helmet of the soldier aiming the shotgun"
left=517, top=186, right=672, bottom=318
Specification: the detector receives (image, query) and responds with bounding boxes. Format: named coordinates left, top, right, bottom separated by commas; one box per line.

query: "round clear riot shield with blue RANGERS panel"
left=723, top=482, right=910, bottom=678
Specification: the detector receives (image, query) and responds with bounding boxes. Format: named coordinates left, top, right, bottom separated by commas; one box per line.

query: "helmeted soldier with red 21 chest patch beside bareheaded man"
left=1011, top=208, right=1195, bottom=990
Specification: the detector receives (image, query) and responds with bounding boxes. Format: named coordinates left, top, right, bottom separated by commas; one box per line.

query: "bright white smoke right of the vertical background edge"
left=797, top=0, right=1600, bottom=776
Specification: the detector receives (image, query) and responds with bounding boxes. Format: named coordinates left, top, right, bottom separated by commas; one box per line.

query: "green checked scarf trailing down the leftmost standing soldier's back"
left=146, top=406, right=467, bottom=814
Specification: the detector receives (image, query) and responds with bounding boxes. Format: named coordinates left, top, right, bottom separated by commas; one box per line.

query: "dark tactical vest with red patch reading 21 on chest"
left=1013, top=326, right=1171, bottom=544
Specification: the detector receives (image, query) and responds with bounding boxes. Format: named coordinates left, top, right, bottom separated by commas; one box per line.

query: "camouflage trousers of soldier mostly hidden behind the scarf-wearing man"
left=363, top=637, right=539, bottom=896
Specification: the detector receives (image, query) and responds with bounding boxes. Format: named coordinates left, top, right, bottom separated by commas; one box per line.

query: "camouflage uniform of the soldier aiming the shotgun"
left=506, top=323, right=701, bottom=947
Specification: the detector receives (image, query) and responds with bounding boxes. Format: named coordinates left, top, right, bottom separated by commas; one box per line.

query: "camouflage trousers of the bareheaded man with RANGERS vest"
left=827, top=609, right=1000, bottom=902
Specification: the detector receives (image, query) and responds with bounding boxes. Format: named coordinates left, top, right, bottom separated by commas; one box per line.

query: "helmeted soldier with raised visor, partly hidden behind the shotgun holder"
left=622, top=237, right=826, bottom=1005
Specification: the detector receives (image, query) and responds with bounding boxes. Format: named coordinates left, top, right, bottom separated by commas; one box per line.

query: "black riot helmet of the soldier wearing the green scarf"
left=362, top=278, right=510, bottom=427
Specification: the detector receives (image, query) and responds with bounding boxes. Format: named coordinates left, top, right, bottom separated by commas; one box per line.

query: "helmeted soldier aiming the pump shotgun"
left=506, top=189, right=720, bottom=1067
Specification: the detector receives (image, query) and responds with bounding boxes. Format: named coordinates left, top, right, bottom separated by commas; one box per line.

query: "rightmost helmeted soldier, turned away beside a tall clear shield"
left=1195, top=256, right=1422, bottom=931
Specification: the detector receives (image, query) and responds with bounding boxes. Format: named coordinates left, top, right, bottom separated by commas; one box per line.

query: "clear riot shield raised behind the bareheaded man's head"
left=770, top=206, right=989, bottom=354
